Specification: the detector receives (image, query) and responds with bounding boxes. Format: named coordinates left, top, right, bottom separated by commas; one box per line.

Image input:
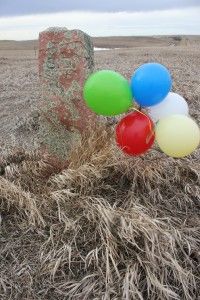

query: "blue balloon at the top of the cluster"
left=131, top=63, right=172, bottom=107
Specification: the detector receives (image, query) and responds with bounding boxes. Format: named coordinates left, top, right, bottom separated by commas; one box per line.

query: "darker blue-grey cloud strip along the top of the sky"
left=0, top=0, right=200, bottom=16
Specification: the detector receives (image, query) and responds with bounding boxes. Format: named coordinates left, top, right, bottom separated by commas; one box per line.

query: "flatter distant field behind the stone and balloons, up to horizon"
left=0, top=36, right=200, bottom=149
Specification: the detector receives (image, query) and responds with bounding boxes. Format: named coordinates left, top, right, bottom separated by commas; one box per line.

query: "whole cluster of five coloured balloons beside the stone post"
left=83, top=63, right=200, bottom=158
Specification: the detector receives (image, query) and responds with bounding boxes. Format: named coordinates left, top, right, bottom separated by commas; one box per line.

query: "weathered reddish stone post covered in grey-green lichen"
left=39, top=27, right=95, bottom=160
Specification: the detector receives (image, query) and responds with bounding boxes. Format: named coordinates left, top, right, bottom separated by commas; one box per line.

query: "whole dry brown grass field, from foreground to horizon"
left=0, top=37, right=200, bottom=300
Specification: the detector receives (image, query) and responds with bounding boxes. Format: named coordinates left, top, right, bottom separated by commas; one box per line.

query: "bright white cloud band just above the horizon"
left=0, top=8, right=200, bottom=40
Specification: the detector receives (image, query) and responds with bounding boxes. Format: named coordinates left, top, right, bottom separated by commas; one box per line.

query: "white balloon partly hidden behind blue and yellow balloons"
left=147, top=92, right=189, bottom=122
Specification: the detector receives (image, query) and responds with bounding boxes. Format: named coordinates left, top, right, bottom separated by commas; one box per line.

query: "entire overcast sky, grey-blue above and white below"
left=0, top=0, right=200, bottom=40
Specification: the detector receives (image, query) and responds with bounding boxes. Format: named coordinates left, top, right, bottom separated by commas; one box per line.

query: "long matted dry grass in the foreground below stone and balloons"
left=0, top=123, right=200, bottom=300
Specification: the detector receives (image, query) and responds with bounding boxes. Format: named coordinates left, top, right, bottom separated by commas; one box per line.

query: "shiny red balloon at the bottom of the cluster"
left=116, top=112, right=155, bottom=155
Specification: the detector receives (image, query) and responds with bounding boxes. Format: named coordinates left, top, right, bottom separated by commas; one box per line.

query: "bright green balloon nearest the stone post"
left=83, top=70, right=133, bottom=116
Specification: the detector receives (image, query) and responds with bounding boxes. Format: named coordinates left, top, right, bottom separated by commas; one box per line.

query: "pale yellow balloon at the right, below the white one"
left=156, top=115, right=200, bottom=158
